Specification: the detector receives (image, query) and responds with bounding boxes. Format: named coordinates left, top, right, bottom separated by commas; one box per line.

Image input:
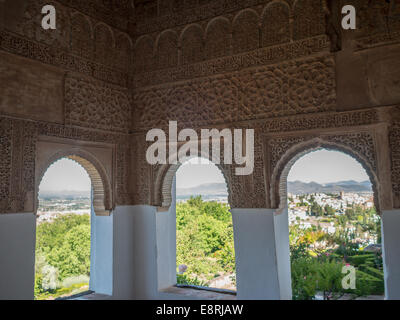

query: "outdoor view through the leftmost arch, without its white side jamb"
left=35, top=158, right=92, bottom=299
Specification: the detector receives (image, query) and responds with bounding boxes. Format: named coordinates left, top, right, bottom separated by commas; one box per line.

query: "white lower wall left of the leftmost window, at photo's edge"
left=0, top=213, right=36, bottom=300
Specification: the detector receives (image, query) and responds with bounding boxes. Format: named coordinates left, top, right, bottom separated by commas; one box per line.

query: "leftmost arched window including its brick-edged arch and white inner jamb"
left=35, top=154, right=113, bottom=300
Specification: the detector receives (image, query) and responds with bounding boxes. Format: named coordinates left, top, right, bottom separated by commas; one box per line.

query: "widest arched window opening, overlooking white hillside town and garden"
left=287, top=148, right=384, bottom=300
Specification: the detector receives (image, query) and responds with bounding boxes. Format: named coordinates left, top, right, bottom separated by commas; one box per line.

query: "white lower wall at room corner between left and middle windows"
left=113, top=206, right=157, bottom=299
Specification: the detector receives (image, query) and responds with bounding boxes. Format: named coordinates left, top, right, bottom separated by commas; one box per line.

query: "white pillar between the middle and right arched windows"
left=231, top=209, right=292, bottom=300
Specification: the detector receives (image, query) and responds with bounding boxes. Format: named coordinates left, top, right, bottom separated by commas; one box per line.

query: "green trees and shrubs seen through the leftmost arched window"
left=35, top=214, right=90, bottom=299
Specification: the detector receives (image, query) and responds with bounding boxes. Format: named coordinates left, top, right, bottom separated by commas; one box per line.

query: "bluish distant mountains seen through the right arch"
left=288, top=180, right=372, bottom=194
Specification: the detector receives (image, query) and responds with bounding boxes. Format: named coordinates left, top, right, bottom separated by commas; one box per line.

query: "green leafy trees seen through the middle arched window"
left=176, top=197, right=235, bottom=286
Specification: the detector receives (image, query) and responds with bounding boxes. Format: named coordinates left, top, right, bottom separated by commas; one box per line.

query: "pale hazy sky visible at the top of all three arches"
left=40, top=150, right=369, bottom=191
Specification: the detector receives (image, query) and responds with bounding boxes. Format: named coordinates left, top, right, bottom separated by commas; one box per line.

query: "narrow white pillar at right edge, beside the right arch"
left=382, top=210, right=400, bottom=300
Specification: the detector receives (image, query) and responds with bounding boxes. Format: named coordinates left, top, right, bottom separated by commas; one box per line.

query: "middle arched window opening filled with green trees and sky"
left=176, top=158, right=236, bottom=291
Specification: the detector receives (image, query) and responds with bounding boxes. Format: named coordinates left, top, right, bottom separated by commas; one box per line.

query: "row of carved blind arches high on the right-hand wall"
left=135, top=0, right=325, bottom=73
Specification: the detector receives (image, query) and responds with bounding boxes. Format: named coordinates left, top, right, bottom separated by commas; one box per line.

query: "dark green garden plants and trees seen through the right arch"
left=289, top=206, right=384, bottom=300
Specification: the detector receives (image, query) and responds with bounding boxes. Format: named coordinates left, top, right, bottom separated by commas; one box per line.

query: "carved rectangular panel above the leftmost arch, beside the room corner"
left=65, top=75, right=131, bottom=132
